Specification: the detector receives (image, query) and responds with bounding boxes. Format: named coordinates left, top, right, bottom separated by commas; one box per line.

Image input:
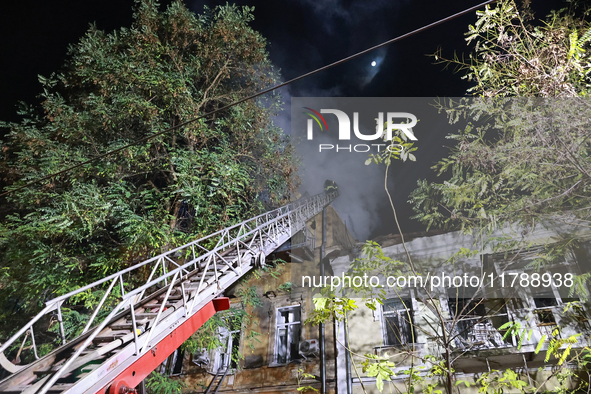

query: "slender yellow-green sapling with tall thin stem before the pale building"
left=310, top=133, right=591, bottom=394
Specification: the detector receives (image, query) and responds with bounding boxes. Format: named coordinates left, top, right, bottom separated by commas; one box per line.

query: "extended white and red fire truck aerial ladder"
left=0, top=190, right=338, bottom=394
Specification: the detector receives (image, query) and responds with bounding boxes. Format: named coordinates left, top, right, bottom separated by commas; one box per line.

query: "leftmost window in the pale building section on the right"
left=382, top=298, right=414, bottom=346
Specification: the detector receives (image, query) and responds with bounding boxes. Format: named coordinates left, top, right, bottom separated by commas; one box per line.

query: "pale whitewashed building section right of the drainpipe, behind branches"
left=332, top=226, right=591, bottom=393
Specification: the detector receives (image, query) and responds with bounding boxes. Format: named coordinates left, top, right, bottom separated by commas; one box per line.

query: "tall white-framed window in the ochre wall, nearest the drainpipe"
left=275, top=305, right=302, bottom=364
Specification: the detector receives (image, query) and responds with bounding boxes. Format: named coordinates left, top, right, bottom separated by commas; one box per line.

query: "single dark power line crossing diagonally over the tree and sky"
left=0, top=0, right=496, bottom=197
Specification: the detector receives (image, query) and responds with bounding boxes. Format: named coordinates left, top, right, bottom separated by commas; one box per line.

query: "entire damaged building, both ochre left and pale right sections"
left=161, top=207, right=591, bottom=393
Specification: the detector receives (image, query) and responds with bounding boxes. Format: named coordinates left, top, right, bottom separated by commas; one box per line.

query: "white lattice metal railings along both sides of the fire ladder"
left=0, top=192, right=338, bottom=393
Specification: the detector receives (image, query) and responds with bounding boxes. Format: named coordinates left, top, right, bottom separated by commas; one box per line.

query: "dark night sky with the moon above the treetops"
left=0, top=0, right=561, bottom=238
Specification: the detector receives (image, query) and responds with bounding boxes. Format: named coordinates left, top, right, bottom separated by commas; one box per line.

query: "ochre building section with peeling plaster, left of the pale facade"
left=159, top=206, right=356, bottom=393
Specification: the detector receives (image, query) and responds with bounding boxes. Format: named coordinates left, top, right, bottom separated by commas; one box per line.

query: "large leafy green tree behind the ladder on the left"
left=0, top=0, right=293, bottom=334
